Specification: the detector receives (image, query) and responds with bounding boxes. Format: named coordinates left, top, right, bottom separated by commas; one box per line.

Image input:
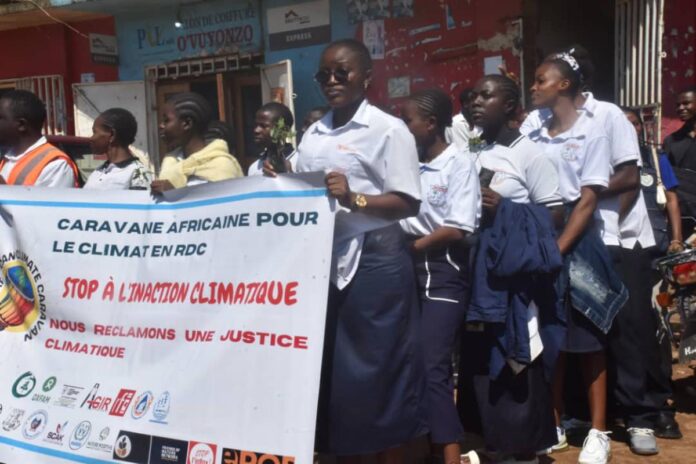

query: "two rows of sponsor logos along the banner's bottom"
left=0, top=371, right=295, bottom=464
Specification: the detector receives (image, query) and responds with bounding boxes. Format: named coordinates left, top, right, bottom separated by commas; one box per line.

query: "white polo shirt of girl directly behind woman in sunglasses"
left=401, top=145, right=481, bottom=237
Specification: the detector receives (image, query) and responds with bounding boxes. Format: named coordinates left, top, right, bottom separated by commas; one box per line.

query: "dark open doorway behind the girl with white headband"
left=524, top=0, right=616, bottom=101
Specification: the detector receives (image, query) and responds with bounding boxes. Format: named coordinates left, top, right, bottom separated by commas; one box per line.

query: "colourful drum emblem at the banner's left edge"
left=0, top=260, right=39, bottom=332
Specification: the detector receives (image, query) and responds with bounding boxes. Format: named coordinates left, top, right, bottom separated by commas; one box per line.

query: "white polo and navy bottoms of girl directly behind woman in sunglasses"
left=401, top=145, right=481, bottom=443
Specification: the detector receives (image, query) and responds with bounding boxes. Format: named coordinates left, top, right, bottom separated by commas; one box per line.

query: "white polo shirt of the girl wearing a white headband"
left=528, top=115, right=611, bottom=203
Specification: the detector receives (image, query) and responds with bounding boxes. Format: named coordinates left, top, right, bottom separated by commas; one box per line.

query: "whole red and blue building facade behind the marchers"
left=0, top=0, right=696, bottom=163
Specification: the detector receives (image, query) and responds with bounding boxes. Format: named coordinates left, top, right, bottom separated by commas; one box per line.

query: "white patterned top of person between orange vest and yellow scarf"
left=83, top=158, right=152, bottom=190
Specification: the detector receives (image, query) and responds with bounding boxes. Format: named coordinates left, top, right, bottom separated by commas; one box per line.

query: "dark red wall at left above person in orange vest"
left=0, top=18, right=118, bottom=134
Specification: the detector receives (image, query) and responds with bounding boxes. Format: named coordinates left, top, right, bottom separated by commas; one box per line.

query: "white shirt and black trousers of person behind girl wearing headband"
left=525, top=93, right=671, bottom=428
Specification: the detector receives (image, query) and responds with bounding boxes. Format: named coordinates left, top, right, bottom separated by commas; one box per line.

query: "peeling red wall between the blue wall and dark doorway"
left=356, top=0, right=522, bottom=113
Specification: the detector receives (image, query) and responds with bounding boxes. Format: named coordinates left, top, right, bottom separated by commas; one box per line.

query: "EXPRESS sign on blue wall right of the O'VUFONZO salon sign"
left=266, top=0, right=331, bottom=51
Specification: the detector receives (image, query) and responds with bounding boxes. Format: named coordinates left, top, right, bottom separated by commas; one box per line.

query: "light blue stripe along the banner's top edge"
left=0, top=188, right=326, bottom=211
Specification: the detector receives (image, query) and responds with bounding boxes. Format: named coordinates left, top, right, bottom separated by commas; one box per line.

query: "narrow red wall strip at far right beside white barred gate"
left=662, top=0, right=696, bottom=137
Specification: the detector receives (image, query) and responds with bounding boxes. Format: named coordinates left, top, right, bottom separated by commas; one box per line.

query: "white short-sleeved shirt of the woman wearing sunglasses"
left=297, top=100, right=421, bottom=288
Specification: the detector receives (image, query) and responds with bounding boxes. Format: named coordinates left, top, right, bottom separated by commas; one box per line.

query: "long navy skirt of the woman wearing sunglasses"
left=316, top=224, right=428, bottom=456
